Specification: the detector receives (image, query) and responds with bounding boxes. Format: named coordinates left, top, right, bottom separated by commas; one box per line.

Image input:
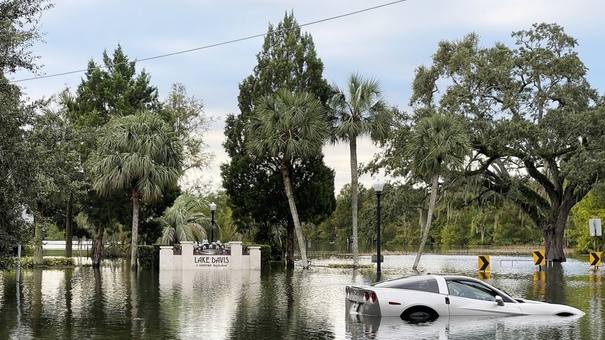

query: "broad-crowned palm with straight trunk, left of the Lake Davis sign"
left=89, top=111, right=182, bottom=269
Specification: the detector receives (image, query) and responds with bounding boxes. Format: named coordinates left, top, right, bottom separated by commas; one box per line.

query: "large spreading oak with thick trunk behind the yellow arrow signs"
left=411, top=24, right=605, bottom=262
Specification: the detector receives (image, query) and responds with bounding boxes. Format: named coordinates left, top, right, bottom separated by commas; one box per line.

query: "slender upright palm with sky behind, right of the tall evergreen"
left=330, top=74, right=392, bottom=267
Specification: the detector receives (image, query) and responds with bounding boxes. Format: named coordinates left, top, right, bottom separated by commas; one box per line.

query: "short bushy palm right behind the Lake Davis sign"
left=161, top=193, right=220, bottom=244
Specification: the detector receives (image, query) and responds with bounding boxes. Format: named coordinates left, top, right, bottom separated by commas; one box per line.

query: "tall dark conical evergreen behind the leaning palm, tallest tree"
left=221, top=13, right=335, bottom=265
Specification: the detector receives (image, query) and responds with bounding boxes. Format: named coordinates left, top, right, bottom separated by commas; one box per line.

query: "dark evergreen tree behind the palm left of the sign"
left=65, top=45, right=179, bottom=265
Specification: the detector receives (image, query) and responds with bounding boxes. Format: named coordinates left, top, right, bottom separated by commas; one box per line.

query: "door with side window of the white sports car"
left=446, top=280, right=522, bottom=316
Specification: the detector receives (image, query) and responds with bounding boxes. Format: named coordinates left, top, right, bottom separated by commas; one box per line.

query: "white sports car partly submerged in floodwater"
left=346, top=274, right=584, bottom=322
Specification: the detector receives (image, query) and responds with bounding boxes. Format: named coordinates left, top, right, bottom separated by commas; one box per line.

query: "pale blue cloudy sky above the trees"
left=9, top=0, right=605, bottom=194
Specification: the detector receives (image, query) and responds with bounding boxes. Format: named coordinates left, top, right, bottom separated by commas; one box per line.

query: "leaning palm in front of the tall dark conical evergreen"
left=247, top=89, right=329, bottom=268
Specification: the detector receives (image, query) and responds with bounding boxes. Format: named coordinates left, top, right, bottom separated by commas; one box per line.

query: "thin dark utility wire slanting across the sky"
left=10, top=0, right=407, bottom=83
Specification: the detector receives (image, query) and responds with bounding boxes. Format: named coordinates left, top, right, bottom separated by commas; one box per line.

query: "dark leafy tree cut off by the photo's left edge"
left=0, top=0, right=51, bottom=268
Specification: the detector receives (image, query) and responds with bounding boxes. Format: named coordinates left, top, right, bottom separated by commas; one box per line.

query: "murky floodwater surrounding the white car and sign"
left=0, top=253, right=605, bottom=340
